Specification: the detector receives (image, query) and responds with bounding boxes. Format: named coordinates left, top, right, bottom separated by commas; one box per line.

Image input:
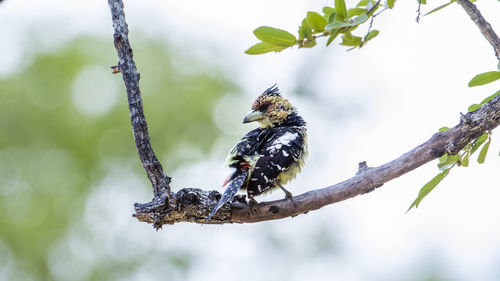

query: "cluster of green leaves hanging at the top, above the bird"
left=245, top=0, right=390, bottom=55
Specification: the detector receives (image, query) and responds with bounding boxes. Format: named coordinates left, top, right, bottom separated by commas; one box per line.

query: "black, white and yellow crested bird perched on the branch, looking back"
left=205, top=85, right=307, bottom=221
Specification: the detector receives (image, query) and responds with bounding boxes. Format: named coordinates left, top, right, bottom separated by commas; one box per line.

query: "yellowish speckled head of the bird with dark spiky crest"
left=243, top=85, right=295, bottom=128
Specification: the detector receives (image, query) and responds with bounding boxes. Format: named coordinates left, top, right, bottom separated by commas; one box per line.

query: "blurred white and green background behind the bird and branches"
left=0, top=0, right=500, bottom=281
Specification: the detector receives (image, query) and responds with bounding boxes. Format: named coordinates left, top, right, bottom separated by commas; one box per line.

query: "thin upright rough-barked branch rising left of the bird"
left=108, top=0, right=170, bottom=226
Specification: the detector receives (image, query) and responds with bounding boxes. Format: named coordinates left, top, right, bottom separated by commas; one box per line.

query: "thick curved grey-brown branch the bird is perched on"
left=134, top=93, right=500, bottom=224
